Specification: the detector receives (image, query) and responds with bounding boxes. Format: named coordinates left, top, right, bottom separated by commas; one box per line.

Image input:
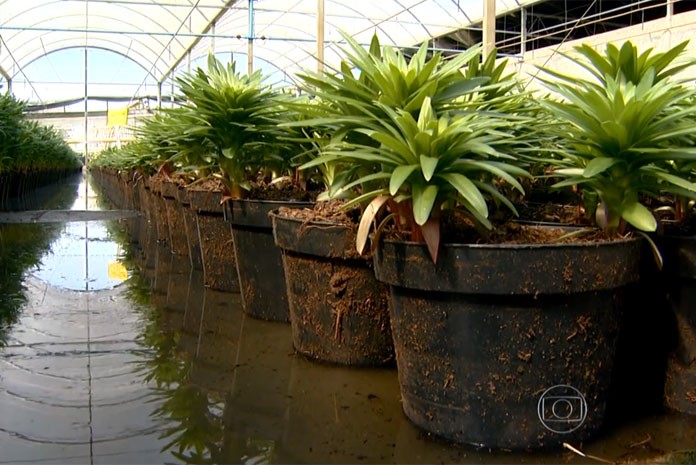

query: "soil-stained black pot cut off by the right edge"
left=662, top=237, right=696, bottom=415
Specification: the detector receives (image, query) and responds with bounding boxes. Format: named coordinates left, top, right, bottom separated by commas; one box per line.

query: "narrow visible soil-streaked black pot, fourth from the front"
left=188, top=189, right=239, bottom=292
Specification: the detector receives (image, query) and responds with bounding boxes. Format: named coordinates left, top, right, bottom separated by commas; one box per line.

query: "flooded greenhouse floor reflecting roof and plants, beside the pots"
left=0, top=172, right=696, bottom=465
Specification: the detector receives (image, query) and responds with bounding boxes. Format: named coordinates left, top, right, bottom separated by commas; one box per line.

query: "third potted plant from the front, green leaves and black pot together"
left=173, top=55, right=311, bottom=322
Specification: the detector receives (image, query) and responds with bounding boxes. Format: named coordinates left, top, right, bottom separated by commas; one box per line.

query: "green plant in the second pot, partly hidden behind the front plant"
left=293, top=33, right=490, bottom=200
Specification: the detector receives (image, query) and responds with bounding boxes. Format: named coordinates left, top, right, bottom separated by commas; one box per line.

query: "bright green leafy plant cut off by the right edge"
left=542, top=42, right=696, bottom=235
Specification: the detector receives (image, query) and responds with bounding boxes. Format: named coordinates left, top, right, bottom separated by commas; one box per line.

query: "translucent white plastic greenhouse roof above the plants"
left=0, top=0, right=536, bottom=89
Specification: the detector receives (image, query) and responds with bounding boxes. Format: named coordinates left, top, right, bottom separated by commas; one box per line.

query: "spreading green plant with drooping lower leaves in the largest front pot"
left=308, top=97, right=529, bottom=261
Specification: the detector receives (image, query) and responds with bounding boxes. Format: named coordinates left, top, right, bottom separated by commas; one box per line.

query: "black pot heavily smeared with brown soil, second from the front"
left=272, top=214, right=394, bottom=366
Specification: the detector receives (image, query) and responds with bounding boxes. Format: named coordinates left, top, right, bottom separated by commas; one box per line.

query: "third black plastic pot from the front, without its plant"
left=225, top=200, right=313, bottom=322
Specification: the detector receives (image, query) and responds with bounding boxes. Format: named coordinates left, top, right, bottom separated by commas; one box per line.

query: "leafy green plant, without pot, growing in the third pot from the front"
left=177, top=54, right=296, bottom=198
